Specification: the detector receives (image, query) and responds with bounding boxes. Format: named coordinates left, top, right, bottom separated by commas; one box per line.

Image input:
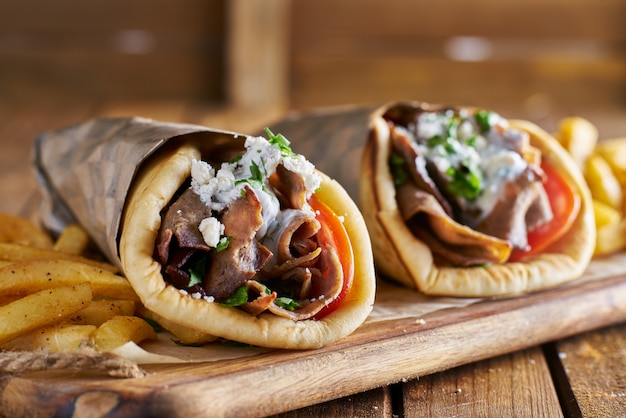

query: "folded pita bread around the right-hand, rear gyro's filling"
left=359, top=103, right=595, bottom=297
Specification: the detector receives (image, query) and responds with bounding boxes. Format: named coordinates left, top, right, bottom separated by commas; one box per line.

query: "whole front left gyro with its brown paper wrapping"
left=37, top=118, right=375, bottom=349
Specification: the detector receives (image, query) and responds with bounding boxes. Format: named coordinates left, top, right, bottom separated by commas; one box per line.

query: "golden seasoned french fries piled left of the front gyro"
left=0, top=214, right=156, bottom=352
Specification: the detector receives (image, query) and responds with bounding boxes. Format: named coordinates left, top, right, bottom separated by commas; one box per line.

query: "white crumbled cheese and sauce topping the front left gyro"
left=191, top=132, right=321, bottom=240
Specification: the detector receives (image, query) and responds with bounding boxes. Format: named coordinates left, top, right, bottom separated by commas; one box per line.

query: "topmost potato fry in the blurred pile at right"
left=555, top=116, right=598, bottom=168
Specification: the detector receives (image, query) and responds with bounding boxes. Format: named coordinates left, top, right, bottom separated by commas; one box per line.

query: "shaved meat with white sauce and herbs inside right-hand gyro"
left=384, top=106, right=553, bottom=265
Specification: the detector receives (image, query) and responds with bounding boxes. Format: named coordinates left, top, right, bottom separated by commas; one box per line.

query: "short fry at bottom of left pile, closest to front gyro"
left=93, top=316, right=157, bottom=352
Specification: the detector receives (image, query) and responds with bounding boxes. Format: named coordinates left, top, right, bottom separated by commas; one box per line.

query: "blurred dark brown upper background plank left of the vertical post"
left=0, top=0, right=225, bottom=103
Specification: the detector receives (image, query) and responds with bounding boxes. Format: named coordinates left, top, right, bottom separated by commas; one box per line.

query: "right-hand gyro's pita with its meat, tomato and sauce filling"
left=360, top=103, right=595, bottom=297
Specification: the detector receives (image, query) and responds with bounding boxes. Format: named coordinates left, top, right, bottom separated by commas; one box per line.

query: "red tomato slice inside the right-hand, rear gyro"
left=509, top=162, right=581, bottom=261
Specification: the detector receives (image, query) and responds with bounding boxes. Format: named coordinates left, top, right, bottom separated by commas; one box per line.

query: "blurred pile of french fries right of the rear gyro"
left=555, top=116, right=626, bottom=256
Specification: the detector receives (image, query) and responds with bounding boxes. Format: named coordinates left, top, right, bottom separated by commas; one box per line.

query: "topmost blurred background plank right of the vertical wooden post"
left=293, top=0, right=626, bottom=40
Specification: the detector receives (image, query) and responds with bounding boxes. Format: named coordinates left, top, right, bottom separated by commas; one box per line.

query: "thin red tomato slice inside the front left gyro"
left=309, top=195, right=354, bottom=319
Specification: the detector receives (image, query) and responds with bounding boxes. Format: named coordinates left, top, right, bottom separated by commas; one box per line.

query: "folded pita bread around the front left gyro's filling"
left=119, top=135, right=375, bottom=349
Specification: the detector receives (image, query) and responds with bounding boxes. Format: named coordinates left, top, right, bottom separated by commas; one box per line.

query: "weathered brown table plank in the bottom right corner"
left=556, top=324, right=626, bottom=417
